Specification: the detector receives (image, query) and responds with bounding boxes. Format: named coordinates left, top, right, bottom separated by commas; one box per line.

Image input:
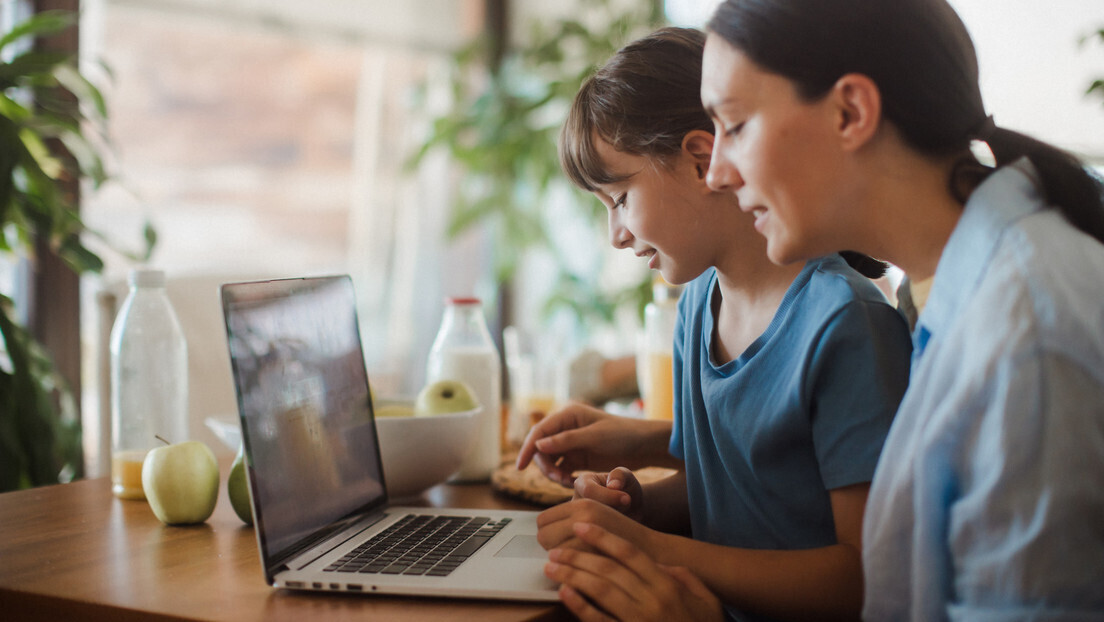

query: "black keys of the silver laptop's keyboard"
left=323, top=514, right=510, bottom=577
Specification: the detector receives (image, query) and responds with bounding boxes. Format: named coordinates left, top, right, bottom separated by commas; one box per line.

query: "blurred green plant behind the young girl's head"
left=412, top=0, right=664, bottom=323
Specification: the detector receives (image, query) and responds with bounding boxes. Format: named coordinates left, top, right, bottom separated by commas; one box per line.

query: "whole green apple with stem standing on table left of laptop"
left=141, top=441, right=219, bottom=525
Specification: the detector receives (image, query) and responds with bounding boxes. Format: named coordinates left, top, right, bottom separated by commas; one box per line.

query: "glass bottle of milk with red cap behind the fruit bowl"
left=426, top=298, right=502, bottom=482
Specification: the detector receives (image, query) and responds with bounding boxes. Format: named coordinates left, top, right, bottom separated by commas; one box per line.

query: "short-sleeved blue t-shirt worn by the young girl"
left=670, top=255, right=911, bottom=550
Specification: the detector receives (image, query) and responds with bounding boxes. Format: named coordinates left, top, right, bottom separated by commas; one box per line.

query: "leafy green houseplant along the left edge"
left=0, top=11, right=153, bottom=491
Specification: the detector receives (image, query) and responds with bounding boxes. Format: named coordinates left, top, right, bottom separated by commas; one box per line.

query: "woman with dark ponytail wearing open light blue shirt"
left=702, top=0, right=1104, bottom=620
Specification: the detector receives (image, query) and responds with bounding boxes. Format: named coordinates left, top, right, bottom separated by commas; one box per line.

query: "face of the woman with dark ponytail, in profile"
left=701, top=34, right=845, bottom=264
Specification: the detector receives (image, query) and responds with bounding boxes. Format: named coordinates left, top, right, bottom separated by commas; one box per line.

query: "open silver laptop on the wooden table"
left=221, top=275, right=558, bottom=601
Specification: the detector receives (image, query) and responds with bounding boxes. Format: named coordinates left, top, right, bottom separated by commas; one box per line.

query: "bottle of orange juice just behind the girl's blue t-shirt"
left=637, top=275, right=682, bottom=420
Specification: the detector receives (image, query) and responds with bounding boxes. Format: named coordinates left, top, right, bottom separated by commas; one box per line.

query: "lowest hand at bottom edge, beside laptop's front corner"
left=544, top=523, right=724, bottom=622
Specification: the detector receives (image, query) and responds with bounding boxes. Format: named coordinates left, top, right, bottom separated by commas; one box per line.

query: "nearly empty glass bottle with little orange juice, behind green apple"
left=110, top=268, right=188, bottom=499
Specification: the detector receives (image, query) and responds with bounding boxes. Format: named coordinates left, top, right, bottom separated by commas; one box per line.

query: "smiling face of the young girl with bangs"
left=594, top=139, right=715, bottom=284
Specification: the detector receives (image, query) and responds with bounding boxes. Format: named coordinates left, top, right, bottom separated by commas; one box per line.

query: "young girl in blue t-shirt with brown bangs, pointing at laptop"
left=519, top=29, right=910, bottom=619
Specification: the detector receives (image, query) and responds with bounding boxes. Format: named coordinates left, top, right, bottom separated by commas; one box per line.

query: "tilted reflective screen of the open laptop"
left=222, top=276, right=386, bottom=571
